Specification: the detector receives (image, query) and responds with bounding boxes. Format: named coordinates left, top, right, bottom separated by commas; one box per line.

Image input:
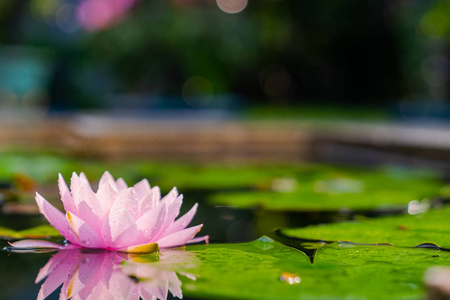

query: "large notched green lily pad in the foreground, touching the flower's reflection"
left=182, top=237, right=450, bottom=299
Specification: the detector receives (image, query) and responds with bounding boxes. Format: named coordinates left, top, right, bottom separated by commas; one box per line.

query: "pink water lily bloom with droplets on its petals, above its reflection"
left=11, top=172, right=208, bottom=253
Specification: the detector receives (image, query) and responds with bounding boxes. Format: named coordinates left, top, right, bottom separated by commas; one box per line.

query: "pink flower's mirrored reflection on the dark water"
left=25, top=249, right=199, bottom=300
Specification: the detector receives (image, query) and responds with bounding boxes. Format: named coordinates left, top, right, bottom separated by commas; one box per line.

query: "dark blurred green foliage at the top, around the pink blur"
left=0, top=0, right=450, bottom=106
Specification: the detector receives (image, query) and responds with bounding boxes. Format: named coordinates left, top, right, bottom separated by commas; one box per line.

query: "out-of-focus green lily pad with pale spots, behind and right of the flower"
left=209, top=168, right=444, bottom=211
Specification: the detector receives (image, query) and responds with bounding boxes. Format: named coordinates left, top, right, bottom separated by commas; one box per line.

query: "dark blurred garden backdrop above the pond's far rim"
left=0, top=0, right=450, bottom=112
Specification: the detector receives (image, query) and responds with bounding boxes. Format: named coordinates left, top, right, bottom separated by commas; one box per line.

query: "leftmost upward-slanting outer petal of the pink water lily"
left=36, top=193, right=77, bottom=244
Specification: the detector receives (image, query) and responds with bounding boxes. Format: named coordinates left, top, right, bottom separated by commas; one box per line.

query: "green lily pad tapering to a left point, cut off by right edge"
left=283, top=208, right=450, bottom=248
